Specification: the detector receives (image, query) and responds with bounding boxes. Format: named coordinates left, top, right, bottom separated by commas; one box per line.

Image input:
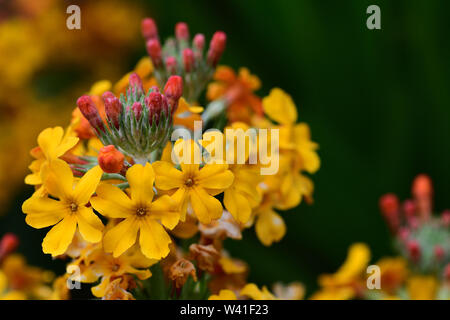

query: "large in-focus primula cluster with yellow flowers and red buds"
left=22, top=18, right=320, bottom=299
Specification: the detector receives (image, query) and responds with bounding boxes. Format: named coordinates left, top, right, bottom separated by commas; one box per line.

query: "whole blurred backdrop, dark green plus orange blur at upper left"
left=0, top=0, right=450, bottom=293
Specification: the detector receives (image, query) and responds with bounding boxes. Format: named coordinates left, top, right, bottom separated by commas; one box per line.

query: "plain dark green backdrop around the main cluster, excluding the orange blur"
left=0, top=0, right=450, bottom=293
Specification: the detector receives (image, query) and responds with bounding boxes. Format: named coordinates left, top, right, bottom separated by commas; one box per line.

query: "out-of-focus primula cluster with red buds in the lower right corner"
left=312, top=174, right=450, bottom=300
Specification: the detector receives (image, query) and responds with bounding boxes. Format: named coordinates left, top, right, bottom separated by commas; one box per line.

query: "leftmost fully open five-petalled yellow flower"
left=22, top=159, right=103, bottom=256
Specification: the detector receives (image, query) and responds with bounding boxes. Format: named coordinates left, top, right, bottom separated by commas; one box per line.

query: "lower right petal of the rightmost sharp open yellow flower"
left=189, top=187, right=223, bottom=224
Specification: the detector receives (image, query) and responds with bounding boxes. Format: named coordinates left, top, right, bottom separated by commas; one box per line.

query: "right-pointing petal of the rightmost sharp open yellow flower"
left=196, top=164, right=234, bottom=189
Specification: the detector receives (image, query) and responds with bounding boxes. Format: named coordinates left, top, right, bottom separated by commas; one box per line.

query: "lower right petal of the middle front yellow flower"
left=139, top=219, right=172, bottom=259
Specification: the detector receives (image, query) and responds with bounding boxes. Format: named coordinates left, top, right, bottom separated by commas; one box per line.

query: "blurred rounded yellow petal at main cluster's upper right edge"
left=262, top=88, right=297, bottom=124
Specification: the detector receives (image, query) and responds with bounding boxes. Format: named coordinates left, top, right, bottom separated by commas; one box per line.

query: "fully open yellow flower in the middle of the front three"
left=91, top=163, right=180, bottom=259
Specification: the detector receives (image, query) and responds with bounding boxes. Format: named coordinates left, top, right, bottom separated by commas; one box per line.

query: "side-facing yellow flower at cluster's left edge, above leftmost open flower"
left=25, top=127, right=79, bottom=185
